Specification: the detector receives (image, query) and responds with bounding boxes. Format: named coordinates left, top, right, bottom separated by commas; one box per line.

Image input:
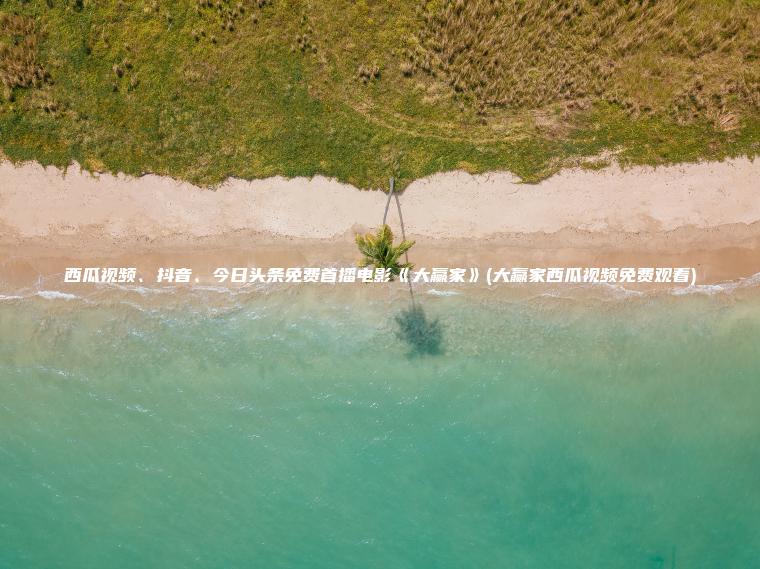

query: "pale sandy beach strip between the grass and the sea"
left=0, top=158, right=760, bottom=288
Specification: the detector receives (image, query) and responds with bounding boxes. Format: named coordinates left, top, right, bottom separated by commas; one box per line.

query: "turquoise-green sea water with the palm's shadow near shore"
left=0, top=287, right=760, bottom=569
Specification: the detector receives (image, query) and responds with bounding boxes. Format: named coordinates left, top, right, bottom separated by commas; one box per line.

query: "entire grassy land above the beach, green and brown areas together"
left=0, top=0, right=760, bottom=187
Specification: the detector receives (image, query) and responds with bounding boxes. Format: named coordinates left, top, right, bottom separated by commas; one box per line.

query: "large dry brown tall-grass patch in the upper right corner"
left=403, top=0, right=760, bottom=120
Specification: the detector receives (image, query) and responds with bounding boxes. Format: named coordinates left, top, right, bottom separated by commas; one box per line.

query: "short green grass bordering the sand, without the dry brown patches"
left=0, top=0, right=760, bottom=188
